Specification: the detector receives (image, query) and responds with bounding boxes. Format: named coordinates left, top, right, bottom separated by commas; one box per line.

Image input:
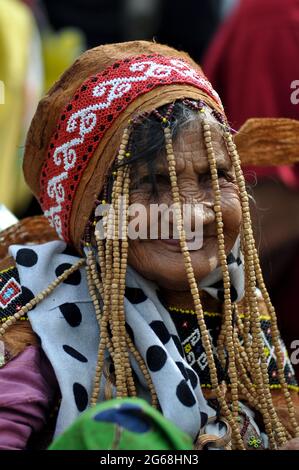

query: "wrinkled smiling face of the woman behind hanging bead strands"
left=128, top=117, right=241, bottom=290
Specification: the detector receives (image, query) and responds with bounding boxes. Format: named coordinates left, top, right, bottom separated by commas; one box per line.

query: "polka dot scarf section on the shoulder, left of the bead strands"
left=10, top=241, right=99, bottom=435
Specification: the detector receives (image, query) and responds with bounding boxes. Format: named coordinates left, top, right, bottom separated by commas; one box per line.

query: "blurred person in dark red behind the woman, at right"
left=204, top=0, right=299, bottom=374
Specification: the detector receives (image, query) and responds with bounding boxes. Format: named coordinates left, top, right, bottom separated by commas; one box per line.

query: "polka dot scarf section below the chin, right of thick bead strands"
left=125, top=266, right=215, bottom=438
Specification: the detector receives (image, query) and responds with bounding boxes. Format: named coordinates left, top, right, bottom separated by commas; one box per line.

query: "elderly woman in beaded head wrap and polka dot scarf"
left=0, top=42, right=299, bottom=449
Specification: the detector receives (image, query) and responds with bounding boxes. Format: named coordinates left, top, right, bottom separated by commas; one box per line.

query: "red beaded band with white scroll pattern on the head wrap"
left=39, top=54, right=222, bottom=242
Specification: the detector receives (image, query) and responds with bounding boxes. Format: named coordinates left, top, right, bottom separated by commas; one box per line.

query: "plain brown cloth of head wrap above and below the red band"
left=24, top=41, right=223, bottom=247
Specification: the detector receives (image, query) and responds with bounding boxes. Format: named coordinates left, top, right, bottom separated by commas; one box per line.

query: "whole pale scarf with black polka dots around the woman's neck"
left=10, top=241, right=244, bottom=438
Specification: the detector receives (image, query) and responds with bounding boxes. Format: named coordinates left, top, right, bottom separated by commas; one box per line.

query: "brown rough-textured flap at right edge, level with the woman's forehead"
left=234, top=118, right=299, bottom=166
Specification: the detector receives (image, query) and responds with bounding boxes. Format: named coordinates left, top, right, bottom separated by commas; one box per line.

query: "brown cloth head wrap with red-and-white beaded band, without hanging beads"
left=24, top=41, right=223, bottom=247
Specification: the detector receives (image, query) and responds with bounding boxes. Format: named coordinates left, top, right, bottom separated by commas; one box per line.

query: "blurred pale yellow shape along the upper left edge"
left=0, top=0, right=41, bottom=211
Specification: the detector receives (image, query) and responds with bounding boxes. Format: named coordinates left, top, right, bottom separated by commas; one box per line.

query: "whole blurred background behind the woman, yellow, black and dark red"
left=0, top=0, right=299, bottom=374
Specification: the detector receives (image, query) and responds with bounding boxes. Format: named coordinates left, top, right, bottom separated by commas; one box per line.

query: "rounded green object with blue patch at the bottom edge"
left=49, top=398, right=193, bottom=450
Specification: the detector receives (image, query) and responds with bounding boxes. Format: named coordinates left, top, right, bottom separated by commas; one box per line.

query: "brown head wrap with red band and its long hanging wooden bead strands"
left=10, top=42, right=299, bottom=449
